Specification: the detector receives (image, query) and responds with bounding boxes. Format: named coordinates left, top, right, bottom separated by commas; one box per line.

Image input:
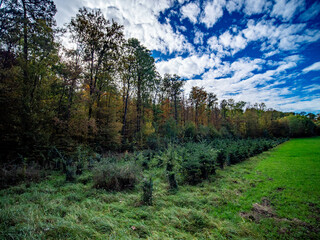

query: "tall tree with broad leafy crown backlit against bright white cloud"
left=68, top=7, right=123, bottom=119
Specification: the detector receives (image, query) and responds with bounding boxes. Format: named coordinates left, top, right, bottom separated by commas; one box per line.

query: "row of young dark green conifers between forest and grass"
left=66, top=139, right=286, bottom=205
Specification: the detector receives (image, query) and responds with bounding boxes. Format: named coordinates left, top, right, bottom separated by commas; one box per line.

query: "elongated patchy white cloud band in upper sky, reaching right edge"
left=207, top=14, right=320, bottom=57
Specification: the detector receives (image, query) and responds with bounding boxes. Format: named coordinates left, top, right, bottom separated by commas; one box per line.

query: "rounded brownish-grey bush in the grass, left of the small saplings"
left=93, top=162, right=141, bottom=191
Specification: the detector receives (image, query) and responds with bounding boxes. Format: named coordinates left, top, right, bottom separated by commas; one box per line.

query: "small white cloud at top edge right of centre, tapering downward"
left=200, top=0, right=226, bottom=28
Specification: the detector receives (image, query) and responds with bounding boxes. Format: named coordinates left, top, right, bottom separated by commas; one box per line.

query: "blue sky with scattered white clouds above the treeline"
left=55, top=0, right=320, bottom=113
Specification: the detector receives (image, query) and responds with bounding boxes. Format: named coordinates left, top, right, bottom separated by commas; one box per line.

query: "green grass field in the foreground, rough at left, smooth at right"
left=0, top=137, right=320, bottom=239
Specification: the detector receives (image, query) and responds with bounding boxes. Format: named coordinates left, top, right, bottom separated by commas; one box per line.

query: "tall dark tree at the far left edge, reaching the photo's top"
left=0, top=0, right=58, bottom=161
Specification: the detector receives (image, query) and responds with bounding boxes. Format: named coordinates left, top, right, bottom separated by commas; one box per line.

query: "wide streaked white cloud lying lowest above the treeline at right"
left=185, top=55, right=300, bottom=110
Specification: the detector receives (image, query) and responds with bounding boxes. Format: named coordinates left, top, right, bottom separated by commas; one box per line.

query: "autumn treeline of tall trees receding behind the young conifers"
left=0, top=0, right=319, bottom=164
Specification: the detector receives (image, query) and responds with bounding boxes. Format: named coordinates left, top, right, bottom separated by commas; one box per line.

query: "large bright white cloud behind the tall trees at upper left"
left=56, top=0, right=194, bottom=53
